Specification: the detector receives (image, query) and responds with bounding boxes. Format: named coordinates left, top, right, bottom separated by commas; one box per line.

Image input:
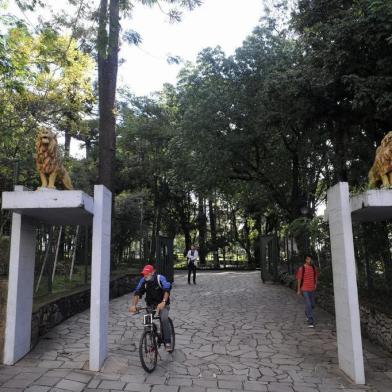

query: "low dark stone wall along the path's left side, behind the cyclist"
left=31, top=275, right=139, bottom=346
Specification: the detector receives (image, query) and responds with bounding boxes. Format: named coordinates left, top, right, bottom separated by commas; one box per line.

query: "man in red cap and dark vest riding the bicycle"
left=129, top=264, right=172, bottom=352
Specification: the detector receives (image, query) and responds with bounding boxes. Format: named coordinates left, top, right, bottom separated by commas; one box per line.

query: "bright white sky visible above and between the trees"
left=0, top=0, right=264, bottom=158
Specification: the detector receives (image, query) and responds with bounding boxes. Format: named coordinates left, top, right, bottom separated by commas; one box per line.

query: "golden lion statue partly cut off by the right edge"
left=368, top=131, right=392, bottom=189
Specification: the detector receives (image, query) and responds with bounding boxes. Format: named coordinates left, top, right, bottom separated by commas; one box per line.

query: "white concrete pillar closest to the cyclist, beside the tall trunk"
left=90, top=185, right=112, bottom=371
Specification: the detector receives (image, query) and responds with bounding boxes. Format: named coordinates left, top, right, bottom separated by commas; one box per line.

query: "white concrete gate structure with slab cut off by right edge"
left=327, top=182, right=392, bottom=384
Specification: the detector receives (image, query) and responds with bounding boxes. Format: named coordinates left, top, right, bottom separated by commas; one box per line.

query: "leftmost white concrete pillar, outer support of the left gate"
left=4, top=186, right=36, bottom=365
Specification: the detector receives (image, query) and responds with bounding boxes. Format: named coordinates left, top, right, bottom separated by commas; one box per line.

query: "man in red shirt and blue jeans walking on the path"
left=296, top=255, right=318, bottom=328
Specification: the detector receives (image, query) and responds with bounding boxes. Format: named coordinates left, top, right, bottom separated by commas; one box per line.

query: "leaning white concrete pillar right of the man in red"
left=327, top=182, right=365, bottom=384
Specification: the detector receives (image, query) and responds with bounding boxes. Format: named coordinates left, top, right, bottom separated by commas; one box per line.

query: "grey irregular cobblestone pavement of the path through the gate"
left=0, top=272, right=392, bottom=392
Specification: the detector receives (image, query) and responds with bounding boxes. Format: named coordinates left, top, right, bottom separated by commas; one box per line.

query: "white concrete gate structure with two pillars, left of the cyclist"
left=2, top=185, right=112, bottom=371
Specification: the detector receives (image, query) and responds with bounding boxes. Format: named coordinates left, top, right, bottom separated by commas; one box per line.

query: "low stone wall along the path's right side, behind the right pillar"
left=281, top=274, right=392, bottom=353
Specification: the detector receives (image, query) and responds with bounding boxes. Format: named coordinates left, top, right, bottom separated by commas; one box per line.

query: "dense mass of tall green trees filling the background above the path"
left=0, top=0, right=392, bottom=298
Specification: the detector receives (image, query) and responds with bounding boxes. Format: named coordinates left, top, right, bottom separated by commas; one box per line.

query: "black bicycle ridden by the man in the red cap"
left=137, top=307, right=176, bottom=373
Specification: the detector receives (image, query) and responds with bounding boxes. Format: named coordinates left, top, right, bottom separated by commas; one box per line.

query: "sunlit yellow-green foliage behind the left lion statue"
left=0, top=19, right=95, bottom=239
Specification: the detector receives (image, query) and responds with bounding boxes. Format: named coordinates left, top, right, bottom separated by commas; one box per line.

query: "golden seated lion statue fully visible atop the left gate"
left=35, top=128, right=73, bottom=189
